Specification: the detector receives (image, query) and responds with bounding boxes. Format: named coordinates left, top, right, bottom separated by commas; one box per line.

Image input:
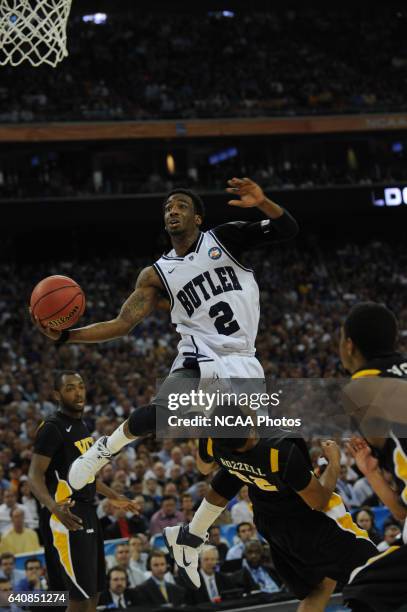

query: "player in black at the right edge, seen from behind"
left=340, top=302, right=407, bottom=612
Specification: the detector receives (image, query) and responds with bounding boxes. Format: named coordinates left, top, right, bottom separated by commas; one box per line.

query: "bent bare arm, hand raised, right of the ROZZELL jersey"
left=297, top=440, right=340, bottom=510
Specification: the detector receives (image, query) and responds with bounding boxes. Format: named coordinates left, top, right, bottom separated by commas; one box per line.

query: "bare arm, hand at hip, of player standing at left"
left=28, top=453, right=82, bottom=531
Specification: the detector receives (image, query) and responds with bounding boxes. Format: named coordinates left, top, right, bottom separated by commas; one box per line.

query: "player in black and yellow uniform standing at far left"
left=29, top=371, right=137, bottom=612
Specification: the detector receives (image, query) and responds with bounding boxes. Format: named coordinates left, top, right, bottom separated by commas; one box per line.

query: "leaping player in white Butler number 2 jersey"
left=31, top=178, right=298, bottom=490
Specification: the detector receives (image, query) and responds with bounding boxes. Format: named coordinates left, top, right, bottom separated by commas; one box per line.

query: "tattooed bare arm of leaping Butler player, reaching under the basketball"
left=34, top=266, right=165, bottom=343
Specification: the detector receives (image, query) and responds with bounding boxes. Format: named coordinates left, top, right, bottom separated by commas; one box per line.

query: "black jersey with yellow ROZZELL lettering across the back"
left=199, top=434, right=313, bottom=514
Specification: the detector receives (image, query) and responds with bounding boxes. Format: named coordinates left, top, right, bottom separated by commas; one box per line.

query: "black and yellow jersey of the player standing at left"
left=34, top=411, right=96, bottom=502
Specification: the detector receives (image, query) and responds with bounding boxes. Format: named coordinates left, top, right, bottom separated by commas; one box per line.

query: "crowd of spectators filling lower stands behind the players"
left=0, top=240, right=407, bottom=605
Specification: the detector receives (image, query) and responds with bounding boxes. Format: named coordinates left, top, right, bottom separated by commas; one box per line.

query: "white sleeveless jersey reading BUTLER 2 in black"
left=154, top=231, right=260, bottom=356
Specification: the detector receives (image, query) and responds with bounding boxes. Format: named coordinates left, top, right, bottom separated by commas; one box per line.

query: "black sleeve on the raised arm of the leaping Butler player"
left=213, top=210, right=298, bottom=259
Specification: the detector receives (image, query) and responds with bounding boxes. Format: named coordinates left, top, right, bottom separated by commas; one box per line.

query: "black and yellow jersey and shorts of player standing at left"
left=34, top=412, right=105, bottom=601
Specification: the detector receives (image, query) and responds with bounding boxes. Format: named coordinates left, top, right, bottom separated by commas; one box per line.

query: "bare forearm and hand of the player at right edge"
left=348, top=437, right=407, bottom=521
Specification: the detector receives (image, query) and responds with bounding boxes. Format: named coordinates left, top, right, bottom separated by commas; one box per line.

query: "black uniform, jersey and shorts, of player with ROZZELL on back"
left=204, top=435, right=377, bottom=599
